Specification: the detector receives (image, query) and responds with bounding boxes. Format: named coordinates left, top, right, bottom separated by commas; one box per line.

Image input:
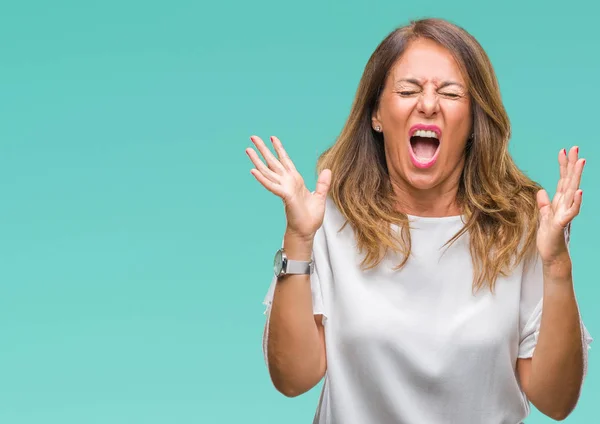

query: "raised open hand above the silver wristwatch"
left=246, top=136, right=331, bottom=241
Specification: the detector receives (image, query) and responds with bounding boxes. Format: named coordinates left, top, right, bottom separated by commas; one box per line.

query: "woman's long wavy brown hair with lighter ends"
left=317, top=19, right=540, bottom=291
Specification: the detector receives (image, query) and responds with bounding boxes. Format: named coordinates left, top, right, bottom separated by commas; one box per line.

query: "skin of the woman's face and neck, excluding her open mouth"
left=372, top=39, right=472, bottom=216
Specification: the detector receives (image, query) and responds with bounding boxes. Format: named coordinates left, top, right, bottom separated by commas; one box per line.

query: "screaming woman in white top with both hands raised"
left=247, top=19, right=591, bottom=424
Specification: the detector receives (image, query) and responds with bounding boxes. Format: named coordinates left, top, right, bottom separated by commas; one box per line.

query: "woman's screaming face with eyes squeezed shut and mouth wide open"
left=372, top=39, right=472, bottom=192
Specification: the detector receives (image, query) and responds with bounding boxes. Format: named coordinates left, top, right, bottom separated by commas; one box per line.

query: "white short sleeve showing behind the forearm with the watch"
left=263, top=227, right=331, bottom=365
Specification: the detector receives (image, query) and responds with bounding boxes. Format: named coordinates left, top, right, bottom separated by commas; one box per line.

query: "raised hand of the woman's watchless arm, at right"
left=537, top=147, right=585, bottom=265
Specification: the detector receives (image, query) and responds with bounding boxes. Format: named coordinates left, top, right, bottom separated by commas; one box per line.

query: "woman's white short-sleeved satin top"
left=263, top=199, right=592, bottom=424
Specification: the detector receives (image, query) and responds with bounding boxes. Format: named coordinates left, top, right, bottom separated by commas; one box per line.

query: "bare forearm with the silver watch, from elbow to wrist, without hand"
left=267, top=230, right=326, bottom=396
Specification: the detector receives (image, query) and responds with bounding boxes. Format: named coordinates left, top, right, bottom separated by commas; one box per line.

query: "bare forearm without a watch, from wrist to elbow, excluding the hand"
left=529, top=256, right=583, bottom=418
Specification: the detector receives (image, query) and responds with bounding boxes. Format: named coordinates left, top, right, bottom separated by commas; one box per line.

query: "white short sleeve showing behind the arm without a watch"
left=518, top=230, right=593, bottom=375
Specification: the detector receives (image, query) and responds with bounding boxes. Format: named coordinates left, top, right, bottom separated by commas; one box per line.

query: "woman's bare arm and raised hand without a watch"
left=517, top=147, right=585, bottom=420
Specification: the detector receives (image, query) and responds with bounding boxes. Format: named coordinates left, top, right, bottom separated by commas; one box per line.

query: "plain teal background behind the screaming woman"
left=0, top=0, right=600, bottom=424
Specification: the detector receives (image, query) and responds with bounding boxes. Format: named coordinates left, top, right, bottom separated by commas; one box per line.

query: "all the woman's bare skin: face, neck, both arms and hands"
left=246, top=40, right=585, bottom=420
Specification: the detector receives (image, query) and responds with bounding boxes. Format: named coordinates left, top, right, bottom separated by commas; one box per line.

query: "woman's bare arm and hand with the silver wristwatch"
left=246, top=136, right=331, bottom=396
